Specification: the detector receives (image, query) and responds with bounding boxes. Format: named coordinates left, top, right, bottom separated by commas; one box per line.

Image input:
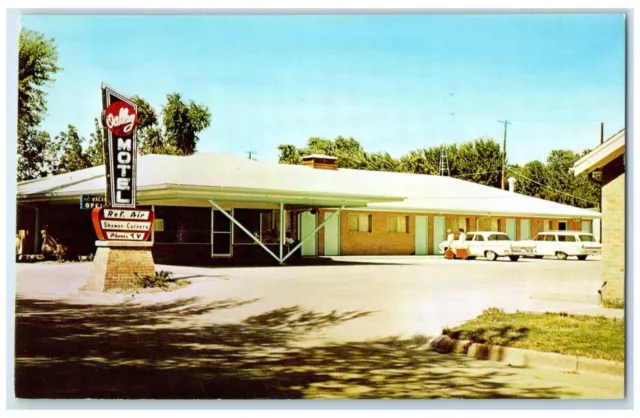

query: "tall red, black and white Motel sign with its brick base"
left=86, top=83, right=155, bottom=291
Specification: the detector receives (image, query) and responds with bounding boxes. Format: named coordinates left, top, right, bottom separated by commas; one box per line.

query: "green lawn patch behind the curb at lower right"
left=443, top=308, right=624, bottom=361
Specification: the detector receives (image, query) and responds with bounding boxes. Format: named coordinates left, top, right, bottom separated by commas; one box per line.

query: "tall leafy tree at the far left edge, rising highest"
left=18, top=29, right=60, bottom=180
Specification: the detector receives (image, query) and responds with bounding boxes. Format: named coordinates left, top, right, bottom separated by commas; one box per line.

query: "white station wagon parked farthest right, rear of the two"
left=535, top=231, right=602, bottom=260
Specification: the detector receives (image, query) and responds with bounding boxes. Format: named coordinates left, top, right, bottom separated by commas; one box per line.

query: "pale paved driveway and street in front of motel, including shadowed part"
left=16, top=257, right=623, bottom=398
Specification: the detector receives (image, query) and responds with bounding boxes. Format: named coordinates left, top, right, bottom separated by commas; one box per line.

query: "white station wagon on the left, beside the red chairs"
left=440, top=231, right=536, bottom=261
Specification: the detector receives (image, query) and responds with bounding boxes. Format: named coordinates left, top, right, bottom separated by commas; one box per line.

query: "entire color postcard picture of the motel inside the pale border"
left=11, top=12, right=628, bottom=399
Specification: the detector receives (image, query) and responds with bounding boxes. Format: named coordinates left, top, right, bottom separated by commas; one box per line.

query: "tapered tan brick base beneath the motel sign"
left=86, top=241, right=155, bottom=292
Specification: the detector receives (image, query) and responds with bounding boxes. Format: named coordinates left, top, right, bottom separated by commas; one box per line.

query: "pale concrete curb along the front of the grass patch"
left=428, top=335, right=625, bottom=376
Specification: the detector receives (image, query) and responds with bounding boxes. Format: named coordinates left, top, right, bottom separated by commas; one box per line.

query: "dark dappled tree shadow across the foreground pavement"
left=15, top=298, right=574, bottom=399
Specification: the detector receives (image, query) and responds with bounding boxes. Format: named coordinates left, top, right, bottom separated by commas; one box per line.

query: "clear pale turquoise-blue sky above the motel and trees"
left=21, top=14, right=626, bottom=164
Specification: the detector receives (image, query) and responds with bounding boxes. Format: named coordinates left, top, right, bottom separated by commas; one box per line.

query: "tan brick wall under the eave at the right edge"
left=602, top=158, right=625, bottom=300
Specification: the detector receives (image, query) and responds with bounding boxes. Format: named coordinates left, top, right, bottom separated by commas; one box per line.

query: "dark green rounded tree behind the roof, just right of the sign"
left=162, top=93, right=211, bottom=155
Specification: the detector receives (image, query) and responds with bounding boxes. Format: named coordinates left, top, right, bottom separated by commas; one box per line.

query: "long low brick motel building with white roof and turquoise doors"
left=17, top=153, right=600, bottom=265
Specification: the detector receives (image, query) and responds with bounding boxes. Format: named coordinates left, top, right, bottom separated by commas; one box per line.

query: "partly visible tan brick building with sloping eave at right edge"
left=574, top=129, right=626, bottom=300
